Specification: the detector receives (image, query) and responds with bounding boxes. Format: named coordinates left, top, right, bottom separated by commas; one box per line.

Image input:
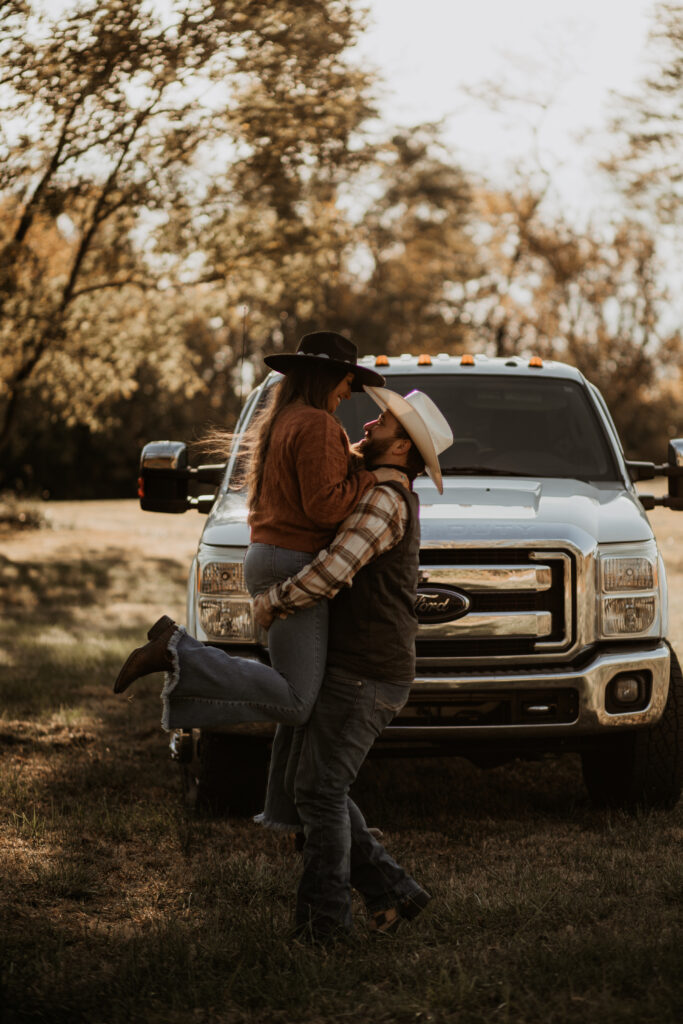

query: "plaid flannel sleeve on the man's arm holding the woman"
left=260, top=484, right=408, bottom=613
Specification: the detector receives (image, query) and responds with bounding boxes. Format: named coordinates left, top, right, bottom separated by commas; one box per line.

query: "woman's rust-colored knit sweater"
left=249, top=403, right=377, bottom=552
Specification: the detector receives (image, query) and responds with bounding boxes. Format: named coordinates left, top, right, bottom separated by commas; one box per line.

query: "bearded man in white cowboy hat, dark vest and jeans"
left=254, top=387, right=453, bottom=942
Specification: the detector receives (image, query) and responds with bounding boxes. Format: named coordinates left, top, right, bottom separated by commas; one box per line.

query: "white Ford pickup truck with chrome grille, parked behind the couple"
left=140, top=354, right=683, bottom=813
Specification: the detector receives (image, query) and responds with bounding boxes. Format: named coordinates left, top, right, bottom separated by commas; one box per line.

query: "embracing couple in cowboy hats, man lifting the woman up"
left=115, top=332, right=453, bottom=942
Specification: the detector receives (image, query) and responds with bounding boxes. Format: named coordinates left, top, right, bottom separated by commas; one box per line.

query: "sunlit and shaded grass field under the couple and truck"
left=0, top=502, right=683, bottom=1024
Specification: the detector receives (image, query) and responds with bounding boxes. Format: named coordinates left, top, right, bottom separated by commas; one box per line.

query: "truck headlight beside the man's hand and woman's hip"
left=197, top=561, right=256, bottom=643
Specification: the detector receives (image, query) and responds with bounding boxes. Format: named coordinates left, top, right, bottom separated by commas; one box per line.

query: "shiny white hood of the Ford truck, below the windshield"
left=202, top=476, right=652, bottom=550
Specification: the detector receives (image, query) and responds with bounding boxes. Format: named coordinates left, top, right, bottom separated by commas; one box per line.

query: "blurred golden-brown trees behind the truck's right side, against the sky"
left=466, top=187, right=683, bottom=458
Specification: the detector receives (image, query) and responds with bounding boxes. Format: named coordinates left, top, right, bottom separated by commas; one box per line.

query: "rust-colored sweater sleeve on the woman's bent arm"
left=295, top=411, right=377, bottom=527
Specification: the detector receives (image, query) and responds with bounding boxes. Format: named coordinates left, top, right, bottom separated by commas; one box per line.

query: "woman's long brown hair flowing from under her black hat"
left=202, top=360, right=348, bottom=509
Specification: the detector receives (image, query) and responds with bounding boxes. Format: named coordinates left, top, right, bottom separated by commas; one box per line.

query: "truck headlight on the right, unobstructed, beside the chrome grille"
left=599, top=542, right=659, bottom=638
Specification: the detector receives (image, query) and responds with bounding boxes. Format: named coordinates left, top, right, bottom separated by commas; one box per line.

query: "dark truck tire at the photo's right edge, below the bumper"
left=582, top=650, right=683, bottom=811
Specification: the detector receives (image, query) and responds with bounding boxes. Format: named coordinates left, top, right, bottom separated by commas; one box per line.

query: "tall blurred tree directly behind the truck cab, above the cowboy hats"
left=329, top=124, right=481, bottom=353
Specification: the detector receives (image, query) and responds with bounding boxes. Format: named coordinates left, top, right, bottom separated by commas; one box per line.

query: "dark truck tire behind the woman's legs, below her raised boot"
left=180, top=729, right=268, bottom=817
